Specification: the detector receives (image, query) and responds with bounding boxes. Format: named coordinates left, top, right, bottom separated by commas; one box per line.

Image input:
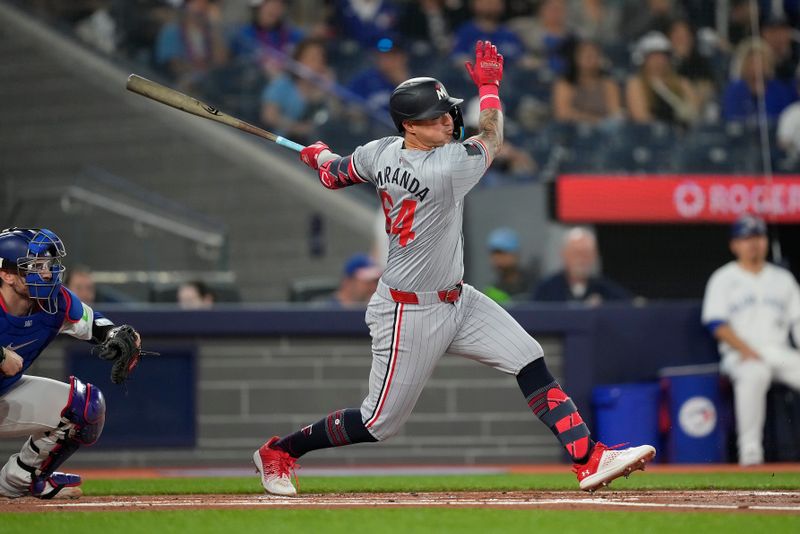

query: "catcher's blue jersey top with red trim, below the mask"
left=0, top=287, right=83, bottom=395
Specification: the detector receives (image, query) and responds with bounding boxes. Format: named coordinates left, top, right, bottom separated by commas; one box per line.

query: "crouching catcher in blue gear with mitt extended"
left=0, top=228, right=147, bottom=499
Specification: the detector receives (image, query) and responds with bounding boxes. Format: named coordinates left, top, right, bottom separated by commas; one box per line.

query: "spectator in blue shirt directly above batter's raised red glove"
left=452, top=0, right=524, bottom=63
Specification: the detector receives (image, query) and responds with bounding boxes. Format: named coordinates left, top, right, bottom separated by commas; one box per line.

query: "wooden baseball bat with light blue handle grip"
left=125, top=74, right=305, bottom=152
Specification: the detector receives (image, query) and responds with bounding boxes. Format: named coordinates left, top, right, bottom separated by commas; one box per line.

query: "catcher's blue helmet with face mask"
left=0, top=228, right=67, bottom=314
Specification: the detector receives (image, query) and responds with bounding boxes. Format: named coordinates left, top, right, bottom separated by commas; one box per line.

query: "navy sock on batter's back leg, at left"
left=273, top=408, right=378, bottom=458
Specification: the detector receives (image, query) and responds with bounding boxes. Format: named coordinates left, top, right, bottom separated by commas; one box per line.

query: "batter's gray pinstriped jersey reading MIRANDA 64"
left=352, top=137, right=489, bottom=292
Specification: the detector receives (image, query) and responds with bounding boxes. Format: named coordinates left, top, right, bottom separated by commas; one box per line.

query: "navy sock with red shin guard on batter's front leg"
left=517, top=358, right=594, bottom=464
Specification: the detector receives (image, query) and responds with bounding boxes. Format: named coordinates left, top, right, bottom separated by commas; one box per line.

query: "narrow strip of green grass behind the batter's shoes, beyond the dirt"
left=83, top=471, right=800, bottom=495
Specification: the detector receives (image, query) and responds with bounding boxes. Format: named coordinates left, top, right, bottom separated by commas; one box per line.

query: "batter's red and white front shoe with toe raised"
left=572, top=442, right=656, bottom=491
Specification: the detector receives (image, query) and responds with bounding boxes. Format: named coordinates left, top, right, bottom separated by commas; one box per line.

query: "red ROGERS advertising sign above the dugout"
left=555, top=174, right=800, bottom=223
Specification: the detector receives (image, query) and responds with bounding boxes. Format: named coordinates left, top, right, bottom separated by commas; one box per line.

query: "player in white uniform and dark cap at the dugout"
left=703, top=215, right=800, bottom=465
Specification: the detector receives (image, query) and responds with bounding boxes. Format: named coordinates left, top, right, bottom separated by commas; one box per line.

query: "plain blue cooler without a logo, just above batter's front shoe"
left=592, top=382, right=661, bottom=458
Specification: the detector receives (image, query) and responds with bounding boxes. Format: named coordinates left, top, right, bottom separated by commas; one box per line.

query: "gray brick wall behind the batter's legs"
left=0, top=337, right=562, bottom=466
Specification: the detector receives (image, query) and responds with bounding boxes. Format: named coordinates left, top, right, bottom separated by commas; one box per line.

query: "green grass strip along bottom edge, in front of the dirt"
left=0, top=508, right=800, bottom=534
